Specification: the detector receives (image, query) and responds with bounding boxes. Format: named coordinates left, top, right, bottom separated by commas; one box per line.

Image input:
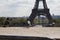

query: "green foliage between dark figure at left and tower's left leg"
left=10, top=18, right=26, bottom=26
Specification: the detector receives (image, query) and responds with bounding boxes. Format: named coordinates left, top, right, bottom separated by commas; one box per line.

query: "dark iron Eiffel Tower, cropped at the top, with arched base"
left=27, top=0, right=55, bottom=26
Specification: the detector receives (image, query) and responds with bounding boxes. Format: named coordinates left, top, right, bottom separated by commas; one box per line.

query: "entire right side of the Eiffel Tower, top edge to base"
left=43, top=0, right=55, bottom=26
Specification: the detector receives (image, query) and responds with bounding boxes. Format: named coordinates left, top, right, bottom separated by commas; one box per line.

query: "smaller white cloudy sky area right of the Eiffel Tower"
left=47, top=0, right=60, bottom=15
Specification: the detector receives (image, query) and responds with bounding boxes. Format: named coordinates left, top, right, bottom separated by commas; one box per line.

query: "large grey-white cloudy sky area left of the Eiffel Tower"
left=0, top=0, right=34, bottom=17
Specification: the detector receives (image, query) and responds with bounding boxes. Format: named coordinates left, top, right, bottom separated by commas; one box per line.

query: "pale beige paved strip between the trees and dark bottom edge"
left=0, top=26, right=60, bottom=38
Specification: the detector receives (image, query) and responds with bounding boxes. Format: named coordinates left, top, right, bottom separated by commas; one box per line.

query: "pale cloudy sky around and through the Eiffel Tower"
left=0, top=0, right=60, bottom=17
